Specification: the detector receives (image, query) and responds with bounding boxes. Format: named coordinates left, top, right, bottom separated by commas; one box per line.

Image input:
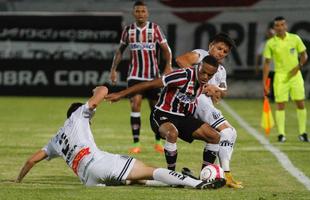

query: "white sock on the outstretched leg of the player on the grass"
left=153, top=168, right=202, bottom=187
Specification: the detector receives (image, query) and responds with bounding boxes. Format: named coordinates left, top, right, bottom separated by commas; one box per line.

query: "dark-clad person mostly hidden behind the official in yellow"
left=255, top=24, right=275, bottom=102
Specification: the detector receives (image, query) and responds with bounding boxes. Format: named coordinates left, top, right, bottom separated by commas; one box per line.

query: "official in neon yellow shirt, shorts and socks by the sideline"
left=263, top=16, right=309, bottom=142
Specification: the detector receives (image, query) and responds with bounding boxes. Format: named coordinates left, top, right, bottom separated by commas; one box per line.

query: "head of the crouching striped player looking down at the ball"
left=198, top=55, right=219, bottom=85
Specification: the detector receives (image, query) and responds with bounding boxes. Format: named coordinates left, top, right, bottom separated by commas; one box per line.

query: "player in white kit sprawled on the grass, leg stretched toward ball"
left=16, top=86, right=225, bottom=189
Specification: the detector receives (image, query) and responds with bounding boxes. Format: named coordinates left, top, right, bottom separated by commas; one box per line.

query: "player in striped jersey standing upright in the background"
left=110, top=1, right=172, bottom=153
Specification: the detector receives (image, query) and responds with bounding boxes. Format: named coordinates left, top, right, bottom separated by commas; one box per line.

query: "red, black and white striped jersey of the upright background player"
left=120, top=22, right=167, bottom=80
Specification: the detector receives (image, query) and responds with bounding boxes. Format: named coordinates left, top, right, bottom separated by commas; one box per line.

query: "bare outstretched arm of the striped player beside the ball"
left=105, top=78, right=164, bottom=102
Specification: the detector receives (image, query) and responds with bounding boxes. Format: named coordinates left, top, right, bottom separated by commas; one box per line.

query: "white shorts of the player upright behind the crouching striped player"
left=194, top=94, right=226, bottom=129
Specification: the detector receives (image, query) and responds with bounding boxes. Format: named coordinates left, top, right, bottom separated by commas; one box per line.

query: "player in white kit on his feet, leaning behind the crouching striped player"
left=176, top=33, right=243, bottom=188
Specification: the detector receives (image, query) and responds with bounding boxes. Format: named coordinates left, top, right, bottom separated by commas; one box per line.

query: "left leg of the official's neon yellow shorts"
left=273, top=73, right=289, bottom=102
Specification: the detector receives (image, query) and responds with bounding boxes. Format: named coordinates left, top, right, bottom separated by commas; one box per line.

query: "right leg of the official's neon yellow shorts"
left=290, top=72, right=305, bottom=101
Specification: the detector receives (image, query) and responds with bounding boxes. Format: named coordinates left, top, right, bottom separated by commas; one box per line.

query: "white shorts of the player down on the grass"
left=81, top=152, right=136, bottom=186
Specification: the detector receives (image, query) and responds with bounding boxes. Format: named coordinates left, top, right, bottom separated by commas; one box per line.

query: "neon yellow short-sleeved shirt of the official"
left=263, top=32, right=306, bottom=74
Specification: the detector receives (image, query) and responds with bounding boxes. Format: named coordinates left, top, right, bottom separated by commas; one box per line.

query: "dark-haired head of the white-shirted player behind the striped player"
left=209, top=33, right=235, bottom=61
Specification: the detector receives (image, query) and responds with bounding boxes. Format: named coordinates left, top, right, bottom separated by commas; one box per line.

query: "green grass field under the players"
left=0, top=97, right=310, bottom=200
